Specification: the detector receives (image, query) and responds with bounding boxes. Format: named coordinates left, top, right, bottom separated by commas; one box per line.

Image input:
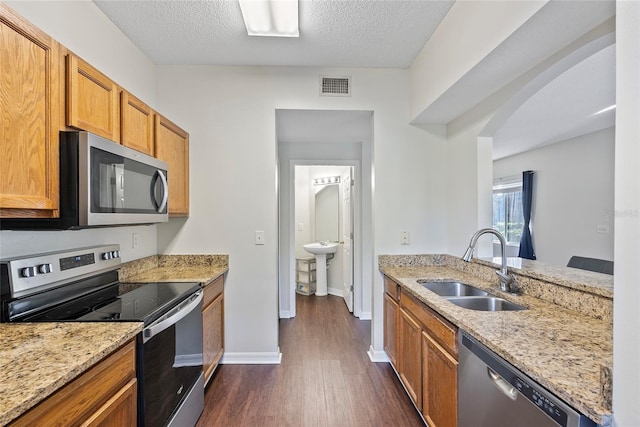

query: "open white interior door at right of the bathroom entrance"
left=342, top=168, right=353, bottom=313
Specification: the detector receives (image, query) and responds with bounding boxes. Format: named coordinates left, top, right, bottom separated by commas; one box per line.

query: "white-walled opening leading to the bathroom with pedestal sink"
left=276, top=110, right=374, bottom=320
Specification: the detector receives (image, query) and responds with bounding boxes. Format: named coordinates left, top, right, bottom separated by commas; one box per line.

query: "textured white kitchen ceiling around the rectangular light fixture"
left=94, top=0, right=453, bottom=68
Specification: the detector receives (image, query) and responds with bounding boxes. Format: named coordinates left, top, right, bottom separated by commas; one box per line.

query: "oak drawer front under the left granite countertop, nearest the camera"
left=11, top=341, right=136, bottom=427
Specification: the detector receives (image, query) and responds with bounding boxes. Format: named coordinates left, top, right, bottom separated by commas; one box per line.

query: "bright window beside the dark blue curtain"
left=493, top=177, right=524, bottom=246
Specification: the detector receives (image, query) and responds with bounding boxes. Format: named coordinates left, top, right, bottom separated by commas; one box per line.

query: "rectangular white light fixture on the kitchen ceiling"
left=238, top=0, right=300, bottom=37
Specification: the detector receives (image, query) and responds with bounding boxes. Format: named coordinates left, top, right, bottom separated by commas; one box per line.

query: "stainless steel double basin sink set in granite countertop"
left=418, top=279, right=527, bottom=311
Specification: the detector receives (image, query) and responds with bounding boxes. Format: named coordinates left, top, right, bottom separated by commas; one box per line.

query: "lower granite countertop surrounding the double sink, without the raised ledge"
left=380, top=266, right=613, bottom=426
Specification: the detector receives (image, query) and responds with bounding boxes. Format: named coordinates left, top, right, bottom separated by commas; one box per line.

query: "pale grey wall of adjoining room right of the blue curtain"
left=493, top=128, right=615, bottom=265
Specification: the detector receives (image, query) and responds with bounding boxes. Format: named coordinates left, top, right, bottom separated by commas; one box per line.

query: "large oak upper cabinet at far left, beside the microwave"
left=0, top=3, right=60, bottom=217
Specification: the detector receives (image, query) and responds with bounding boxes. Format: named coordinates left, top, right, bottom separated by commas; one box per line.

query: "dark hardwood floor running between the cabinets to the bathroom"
left=197, top=295, right=423, bottom=427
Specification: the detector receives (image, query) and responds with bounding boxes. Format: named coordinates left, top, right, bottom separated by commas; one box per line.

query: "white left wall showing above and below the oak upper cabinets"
left=0, top=0, right=159, bottom=261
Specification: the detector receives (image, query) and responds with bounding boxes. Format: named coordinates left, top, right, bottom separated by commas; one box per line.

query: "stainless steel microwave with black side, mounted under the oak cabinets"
left=0, top=131, right=169, bottom=230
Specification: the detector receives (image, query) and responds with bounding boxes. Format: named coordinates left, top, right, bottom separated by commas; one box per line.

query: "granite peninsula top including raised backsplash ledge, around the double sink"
left=379, top=255, right=613, bottom=426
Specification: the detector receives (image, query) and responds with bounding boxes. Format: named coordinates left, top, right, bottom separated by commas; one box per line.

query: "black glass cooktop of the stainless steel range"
left=22, top=282, right=200, bottom=324
